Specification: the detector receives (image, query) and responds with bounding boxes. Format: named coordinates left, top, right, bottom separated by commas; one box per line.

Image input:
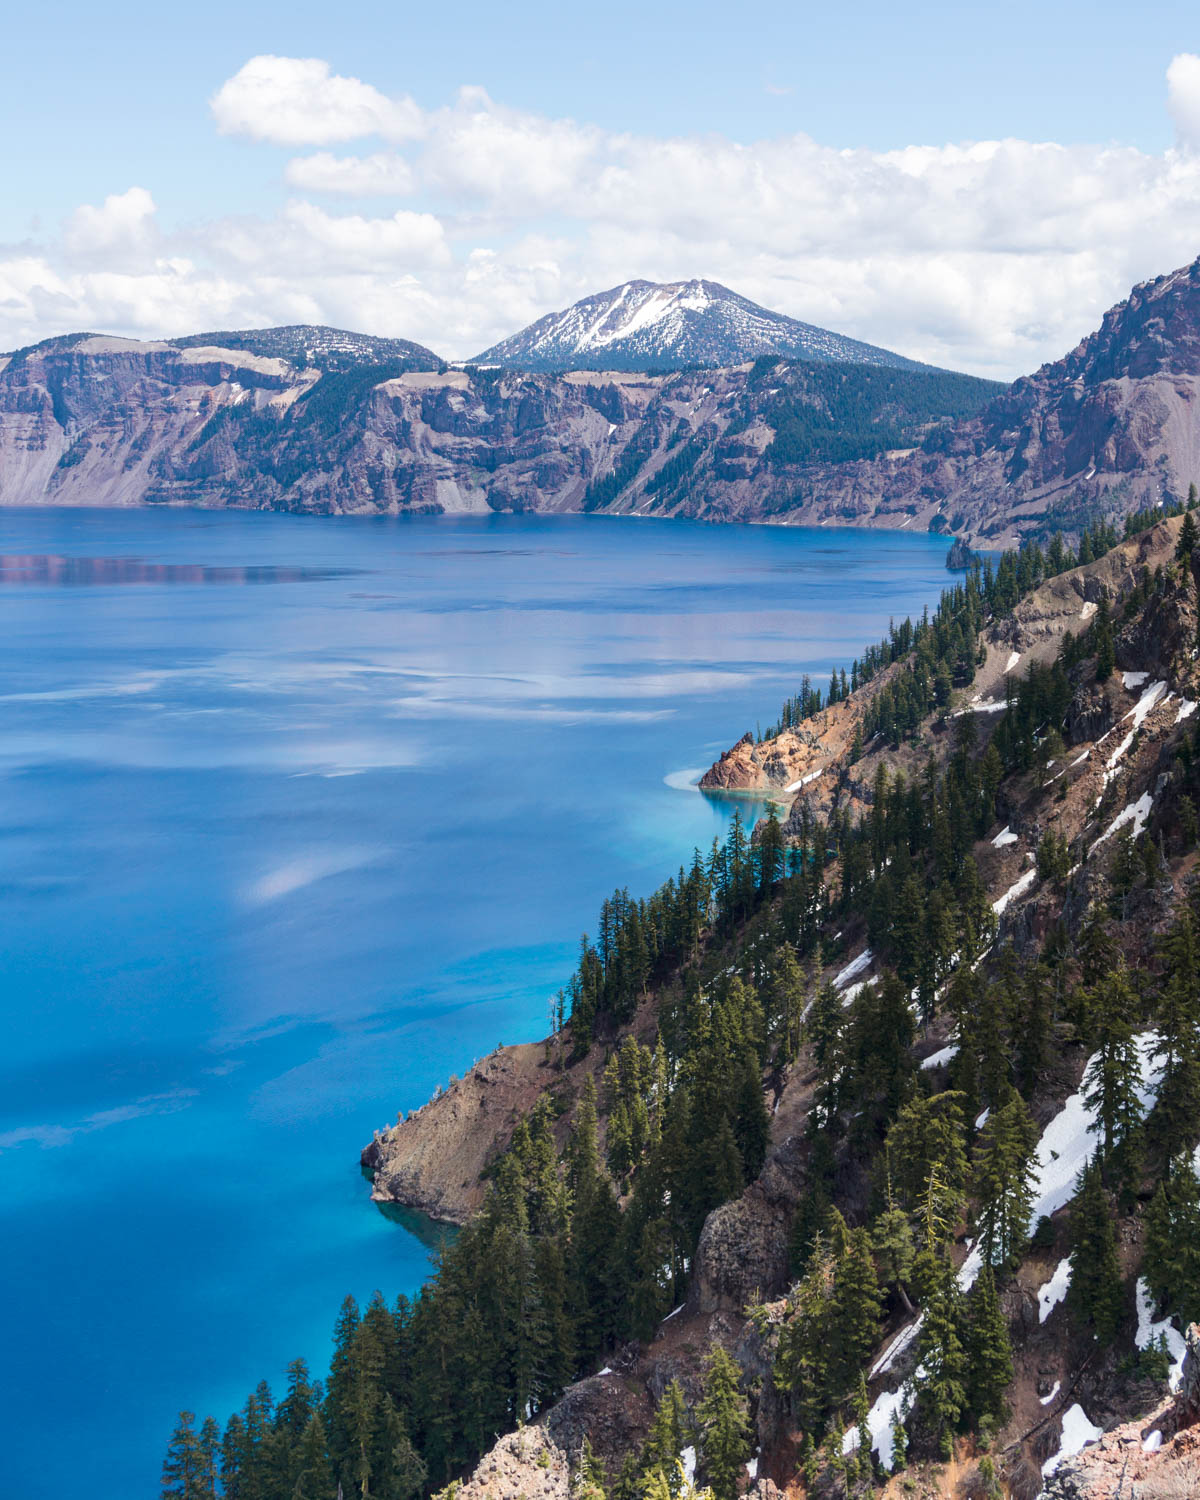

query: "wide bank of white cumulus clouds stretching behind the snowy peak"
left=0, top=54, right=1200, bottom=378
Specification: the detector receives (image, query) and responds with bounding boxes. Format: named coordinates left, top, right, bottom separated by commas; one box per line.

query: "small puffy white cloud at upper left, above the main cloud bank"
left=210, top=54, right=422, bottom=146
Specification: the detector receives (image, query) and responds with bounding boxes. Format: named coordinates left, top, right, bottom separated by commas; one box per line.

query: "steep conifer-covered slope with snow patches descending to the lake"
left=167, top=513, right=1200, bottom=1500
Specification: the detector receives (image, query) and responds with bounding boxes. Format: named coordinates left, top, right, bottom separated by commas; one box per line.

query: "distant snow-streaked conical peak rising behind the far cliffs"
left=471, top=281, right=929, bottom=371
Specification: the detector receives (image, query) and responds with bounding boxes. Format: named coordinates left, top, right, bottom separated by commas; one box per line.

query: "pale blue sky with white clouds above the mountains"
left=0, top=0, right=1200, bottom=375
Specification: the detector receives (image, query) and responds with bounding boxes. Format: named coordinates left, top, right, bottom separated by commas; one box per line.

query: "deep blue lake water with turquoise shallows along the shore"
left=0, top=510, right=947, bottom=1500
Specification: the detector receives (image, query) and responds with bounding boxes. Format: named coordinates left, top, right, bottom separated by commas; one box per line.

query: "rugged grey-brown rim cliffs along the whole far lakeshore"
left=0, top=261, right=1200, bottom=543
